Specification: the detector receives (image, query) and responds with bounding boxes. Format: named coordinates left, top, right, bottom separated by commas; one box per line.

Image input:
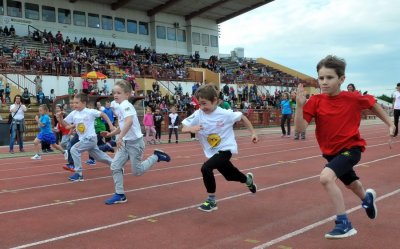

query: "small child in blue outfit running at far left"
left=31, top=105, right=68, bottom=160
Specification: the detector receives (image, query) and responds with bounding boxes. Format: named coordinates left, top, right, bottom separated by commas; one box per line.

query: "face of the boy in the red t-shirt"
left=318, top=67, right=345, bottom=96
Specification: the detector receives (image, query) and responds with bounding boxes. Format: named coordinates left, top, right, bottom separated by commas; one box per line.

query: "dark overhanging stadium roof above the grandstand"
left=74, top=0, right=273, bottom=24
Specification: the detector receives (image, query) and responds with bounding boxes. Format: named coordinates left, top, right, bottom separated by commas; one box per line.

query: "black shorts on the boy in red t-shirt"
left=323, top=147, right=361, bottom=186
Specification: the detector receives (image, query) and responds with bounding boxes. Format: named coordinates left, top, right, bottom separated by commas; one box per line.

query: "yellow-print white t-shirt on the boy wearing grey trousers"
left=64, top=108, right=101, bottom=140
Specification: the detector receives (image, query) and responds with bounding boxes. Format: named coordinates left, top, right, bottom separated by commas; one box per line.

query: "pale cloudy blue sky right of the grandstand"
left=219, top=0, right=400, bottom=96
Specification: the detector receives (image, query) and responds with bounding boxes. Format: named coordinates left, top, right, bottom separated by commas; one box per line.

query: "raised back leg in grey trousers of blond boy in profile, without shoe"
left=125, top=138, right=158, bottom=176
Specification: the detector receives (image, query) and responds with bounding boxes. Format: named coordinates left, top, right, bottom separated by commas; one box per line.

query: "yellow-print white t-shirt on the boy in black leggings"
left=182, top=107, right=243, bottom=158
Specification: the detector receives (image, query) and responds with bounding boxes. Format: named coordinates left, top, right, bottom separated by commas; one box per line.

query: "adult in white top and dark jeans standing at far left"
left=10, top=95, right=26, bottom=154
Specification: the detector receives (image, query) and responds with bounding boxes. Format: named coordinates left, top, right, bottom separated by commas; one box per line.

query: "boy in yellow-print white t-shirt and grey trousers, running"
left=56, top=93, right=115, bottom=182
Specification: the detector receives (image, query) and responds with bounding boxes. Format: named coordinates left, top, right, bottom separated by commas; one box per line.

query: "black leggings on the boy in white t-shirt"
left=201, top=151, right=247, bottom=194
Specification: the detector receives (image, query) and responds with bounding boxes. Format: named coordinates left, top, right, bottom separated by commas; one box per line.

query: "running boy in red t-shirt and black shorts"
left=295, top=55, right=395, bottom=239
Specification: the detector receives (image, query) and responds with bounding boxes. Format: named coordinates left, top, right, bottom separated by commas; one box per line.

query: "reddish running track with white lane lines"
left=0, top=123, right=400, bottom=249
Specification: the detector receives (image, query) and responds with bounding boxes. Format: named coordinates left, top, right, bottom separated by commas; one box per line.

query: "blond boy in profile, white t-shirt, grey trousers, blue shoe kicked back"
left=102, top=80, right=171, bottom=205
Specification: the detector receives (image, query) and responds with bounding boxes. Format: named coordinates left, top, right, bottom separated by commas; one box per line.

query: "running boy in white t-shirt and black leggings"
left=182, top=85, right=258, bottom=212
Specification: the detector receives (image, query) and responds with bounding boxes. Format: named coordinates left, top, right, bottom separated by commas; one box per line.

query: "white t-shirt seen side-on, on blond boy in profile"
left=116, top=100, right=143, bottom=141
